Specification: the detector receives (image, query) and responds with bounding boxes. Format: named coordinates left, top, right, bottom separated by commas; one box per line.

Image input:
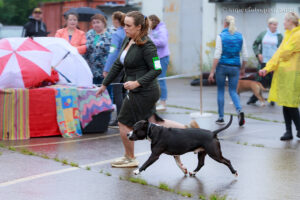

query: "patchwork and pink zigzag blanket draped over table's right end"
left=53, top=86, right=113, bottom=138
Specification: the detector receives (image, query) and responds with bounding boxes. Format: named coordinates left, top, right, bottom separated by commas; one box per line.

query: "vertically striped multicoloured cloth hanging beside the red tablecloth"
left=0, top=89, right=30, bottom=140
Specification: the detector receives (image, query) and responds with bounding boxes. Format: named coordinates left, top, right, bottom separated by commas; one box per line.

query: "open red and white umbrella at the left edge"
left=0, top=38, right=52, bottom=88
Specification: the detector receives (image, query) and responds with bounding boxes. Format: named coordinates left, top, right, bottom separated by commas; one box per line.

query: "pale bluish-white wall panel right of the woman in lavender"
left=163, top=0, right=202, bottom=73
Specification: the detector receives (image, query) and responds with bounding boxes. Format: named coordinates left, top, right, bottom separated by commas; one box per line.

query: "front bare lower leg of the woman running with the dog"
left=118, top=122, right=134, bottom=158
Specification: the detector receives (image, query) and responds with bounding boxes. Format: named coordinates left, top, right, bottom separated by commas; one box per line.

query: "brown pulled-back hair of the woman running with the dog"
left=126, top=11, right=149, bottom=45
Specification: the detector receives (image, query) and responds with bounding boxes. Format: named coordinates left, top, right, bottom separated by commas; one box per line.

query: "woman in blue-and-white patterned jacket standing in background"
left=85, top=14, right=111, bottom=84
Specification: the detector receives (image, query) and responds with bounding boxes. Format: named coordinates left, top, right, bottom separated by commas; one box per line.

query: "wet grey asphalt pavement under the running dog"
left=0, top=79, right=300, bottom=200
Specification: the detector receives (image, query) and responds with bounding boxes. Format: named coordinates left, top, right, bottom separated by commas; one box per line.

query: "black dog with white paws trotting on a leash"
left=127, top=115, right=238, bottom=176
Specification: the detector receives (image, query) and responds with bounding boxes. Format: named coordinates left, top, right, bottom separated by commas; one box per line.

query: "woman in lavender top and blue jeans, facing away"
left=149, top=15, right=170, bottom=111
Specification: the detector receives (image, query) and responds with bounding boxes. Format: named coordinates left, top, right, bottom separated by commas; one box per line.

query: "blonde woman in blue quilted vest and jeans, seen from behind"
left=208, top=16, right=248, bottom=126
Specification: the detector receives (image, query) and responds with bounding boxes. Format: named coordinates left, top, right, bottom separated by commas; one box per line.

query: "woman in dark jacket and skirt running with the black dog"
left=97, top=11, right=195, bottom=167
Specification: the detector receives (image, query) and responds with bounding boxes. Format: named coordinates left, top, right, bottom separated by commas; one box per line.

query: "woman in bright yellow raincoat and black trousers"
left=259, top=12, right=300, bottom=141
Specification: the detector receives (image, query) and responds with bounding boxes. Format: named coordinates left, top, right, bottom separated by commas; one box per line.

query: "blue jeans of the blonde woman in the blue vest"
left=216, top=65, right=242, bottom=118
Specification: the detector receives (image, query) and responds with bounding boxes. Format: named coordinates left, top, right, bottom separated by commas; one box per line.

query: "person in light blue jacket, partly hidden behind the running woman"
left=103, top=11, right=126, bottom=126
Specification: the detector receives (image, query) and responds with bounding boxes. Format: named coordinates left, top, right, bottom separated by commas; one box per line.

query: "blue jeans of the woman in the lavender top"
left=158, top=56, right=169, bottom=101
